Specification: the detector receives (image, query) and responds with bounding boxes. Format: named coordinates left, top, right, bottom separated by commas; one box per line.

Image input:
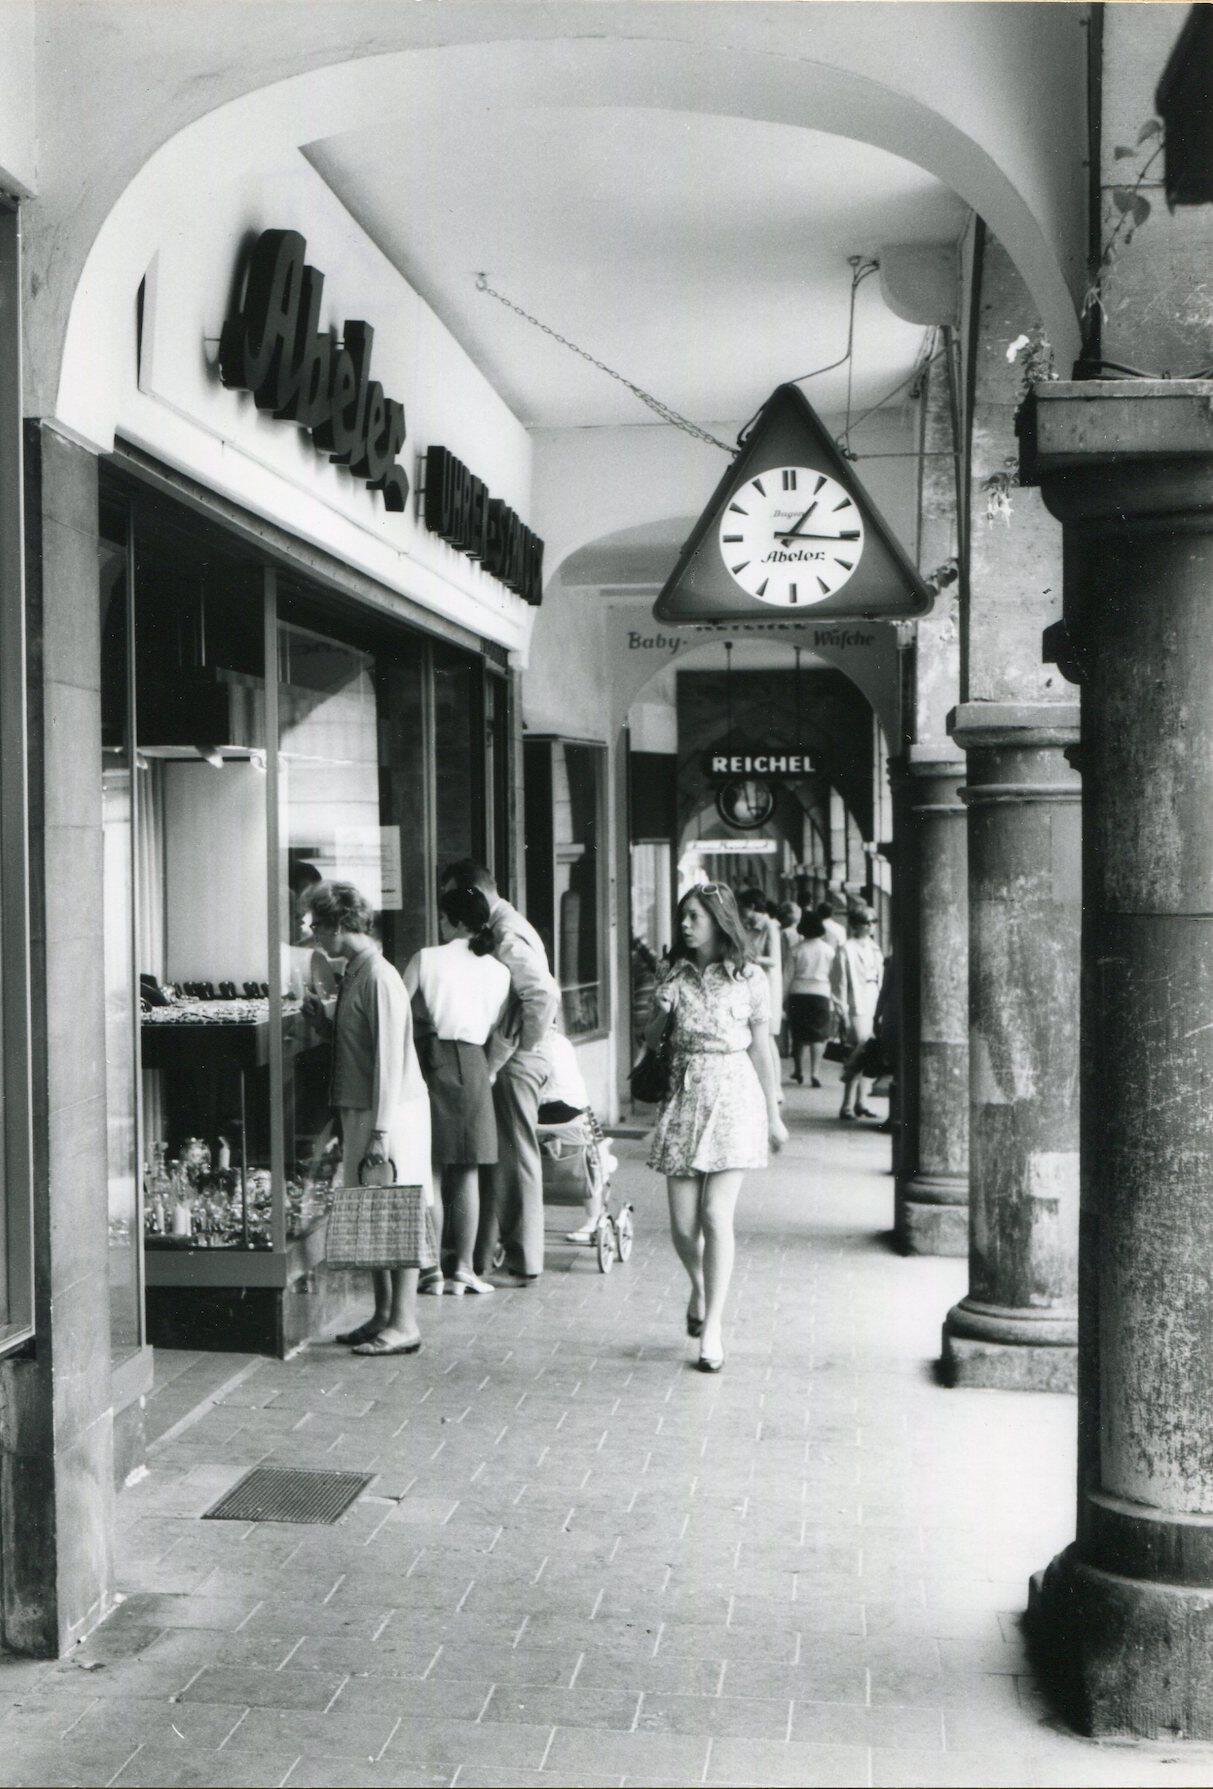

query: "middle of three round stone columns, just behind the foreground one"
left=943, top=701, right=1082, bottom=1392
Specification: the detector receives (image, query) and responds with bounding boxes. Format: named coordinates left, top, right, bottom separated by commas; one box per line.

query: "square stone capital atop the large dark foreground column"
left=1016, top=379, right=1213, bottom=533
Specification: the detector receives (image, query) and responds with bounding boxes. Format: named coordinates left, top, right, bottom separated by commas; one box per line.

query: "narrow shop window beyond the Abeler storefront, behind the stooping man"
left=524, top=739, right=610, bottom=1038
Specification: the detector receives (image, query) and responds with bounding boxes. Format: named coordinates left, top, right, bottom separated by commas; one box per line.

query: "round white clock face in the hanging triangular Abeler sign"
left=719, top=465, right=864, bottom=608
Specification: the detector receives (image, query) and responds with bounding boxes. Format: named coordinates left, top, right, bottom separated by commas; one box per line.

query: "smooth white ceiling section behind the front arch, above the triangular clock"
left=308, top=109, right=968, bottom=428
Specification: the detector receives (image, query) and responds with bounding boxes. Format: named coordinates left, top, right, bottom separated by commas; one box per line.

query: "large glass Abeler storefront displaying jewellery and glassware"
left=100, top=475, right=501, bottom=1356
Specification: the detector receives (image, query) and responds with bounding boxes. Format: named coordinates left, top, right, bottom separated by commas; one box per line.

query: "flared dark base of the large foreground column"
left=1027, top=1547, right=1213, bottom=1739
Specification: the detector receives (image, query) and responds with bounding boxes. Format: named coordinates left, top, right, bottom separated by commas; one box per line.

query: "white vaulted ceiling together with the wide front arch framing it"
left=42, top=0, right=1084, bottom=447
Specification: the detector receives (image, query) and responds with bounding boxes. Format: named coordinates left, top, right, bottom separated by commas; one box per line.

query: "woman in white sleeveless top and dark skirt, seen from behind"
left=404, top=887, right=510, bottom=1297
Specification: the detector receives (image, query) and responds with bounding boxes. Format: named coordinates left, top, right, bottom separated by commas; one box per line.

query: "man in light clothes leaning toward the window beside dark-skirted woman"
left=442, top=857, right=560, bottom=1286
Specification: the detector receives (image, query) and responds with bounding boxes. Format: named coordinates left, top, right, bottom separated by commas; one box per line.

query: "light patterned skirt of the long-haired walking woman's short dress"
left=649, top=1050, right=768, bottom=1174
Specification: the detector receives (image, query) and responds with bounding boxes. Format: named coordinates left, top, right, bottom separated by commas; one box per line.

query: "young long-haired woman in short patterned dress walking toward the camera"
left=644, top=882, right=787, bottom=1372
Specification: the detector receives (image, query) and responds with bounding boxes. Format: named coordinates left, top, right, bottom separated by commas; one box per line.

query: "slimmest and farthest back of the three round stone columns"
left=895, top=746, right=968, bottom=1254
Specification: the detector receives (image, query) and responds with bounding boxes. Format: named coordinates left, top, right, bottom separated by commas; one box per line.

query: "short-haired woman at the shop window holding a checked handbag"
left=304, top=882, right=431, bottom=1354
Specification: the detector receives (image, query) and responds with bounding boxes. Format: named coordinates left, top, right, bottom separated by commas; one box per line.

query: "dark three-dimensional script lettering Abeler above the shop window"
left=218, top=229, right=418, bottom=513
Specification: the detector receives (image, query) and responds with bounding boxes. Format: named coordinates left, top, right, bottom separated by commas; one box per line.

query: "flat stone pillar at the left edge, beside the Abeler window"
left=0, top=422, right=115, bottom=1657
